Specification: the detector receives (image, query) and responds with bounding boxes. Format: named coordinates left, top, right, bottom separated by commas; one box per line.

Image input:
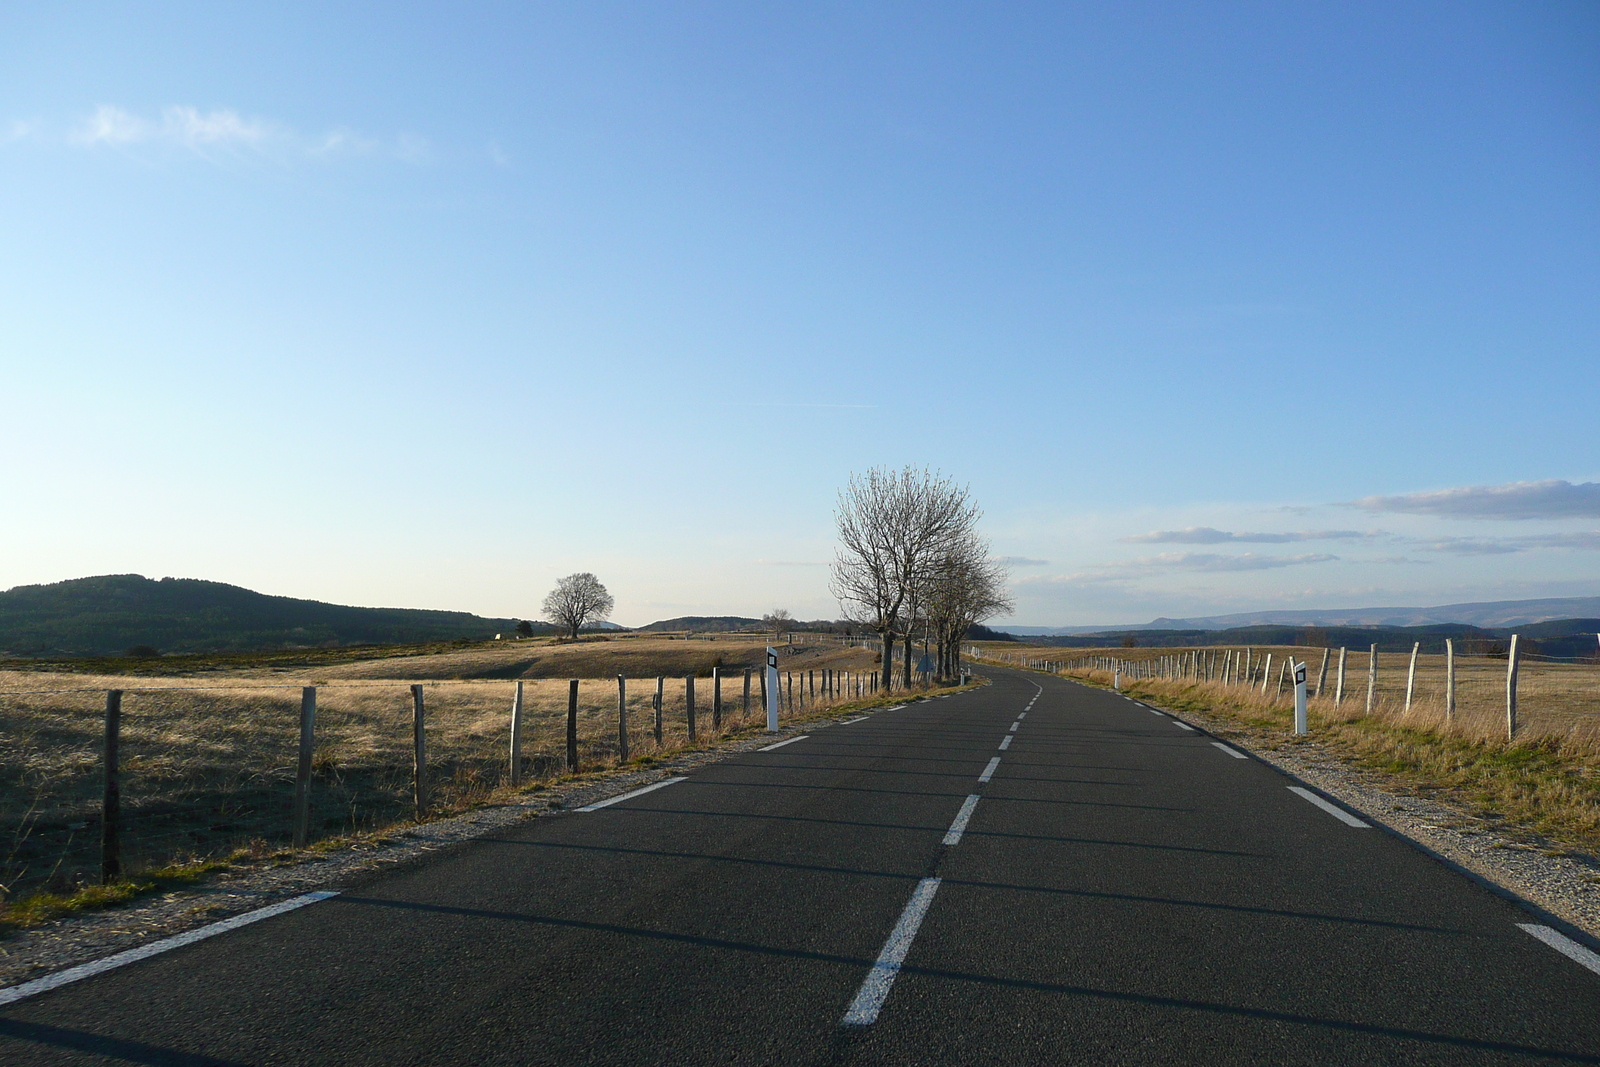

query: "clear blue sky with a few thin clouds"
left=0, top=3, right=1600, bottom=624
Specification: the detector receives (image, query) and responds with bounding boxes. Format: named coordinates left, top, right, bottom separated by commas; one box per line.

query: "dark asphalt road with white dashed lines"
left=0, top=670, right=1600, bottom=1067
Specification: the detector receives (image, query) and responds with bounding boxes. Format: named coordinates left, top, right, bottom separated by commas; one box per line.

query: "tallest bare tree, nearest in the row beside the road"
left=829, top=467, right=981, bottom=686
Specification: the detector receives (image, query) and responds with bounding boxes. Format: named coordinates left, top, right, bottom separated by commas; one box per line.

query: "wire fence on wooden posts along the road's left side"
left=0, top=670, right=878, bottom=899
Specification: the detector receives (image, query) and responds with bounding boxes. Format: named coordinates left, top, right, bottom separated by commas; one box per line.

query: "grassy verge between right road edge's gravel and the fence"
left=1036, top=673, right=1600, bottom=857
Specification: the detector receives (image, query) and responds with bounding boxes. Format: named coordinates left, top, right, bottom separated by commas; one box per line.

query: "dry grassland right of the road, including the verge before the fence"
left=966, top=645, right=1600, bottom=856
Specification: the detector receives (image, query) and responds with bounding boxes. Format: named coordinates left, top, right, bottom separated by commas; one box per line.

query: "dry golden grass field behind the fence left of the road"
left=0, top=637, right=875, bottom=899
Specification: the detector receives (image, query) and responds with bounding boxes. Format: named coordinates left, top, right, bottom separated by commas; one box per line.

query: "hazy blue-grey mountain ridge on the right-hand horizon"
left=997, top=597, right=1600, bottom=637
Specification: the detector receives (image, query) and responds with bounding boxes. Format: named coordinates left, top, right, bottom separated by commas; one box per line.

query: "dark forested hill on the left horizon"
left=0, top=574, right=531, bottom=656
